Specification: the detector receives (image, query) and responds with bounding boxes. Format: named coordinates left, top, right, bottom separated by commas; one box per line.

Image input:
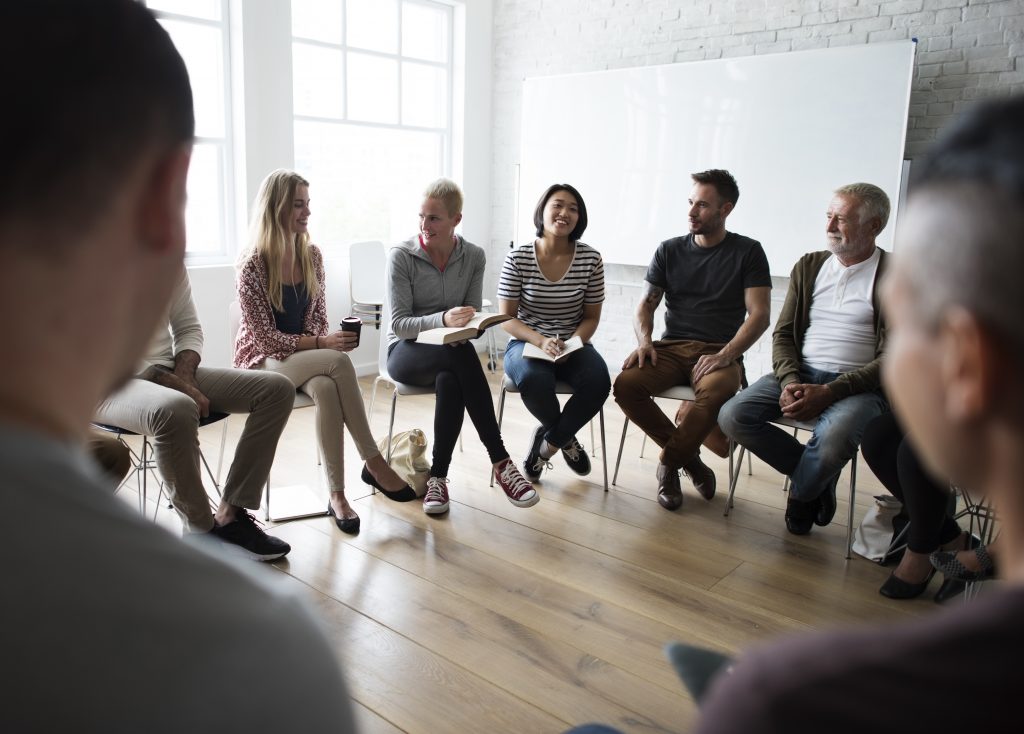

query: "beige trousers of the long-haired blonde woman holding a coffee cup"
left=263, top=349, right=380, bottom=491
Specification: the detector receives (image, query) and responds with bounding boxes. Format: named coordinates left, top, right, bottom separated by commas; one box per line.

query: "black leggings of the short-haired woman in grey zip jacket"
left=387, top=341, right=509, bottom=477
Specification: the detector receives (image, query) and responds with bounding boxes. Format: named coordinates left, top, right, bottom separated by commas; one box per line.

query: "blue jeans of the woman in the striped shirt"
left=505, top=339, right=611, bottom=447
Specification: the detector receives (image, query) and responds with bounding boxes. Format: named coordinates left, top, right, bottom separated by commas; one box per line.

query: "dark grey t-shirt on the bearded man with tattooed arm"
left=644, top=232, right=771, bottom=344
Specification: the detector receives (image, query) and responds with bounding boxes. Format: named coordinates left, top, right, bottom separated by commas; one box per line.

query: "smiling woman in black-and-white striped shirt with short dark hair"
left=498, top=183, right=611, bottom=481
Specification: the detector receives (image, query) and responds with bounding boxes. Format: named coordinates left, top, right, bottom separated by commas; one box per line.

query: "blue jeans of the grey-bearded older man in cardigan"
left=718, top=366, right=889, bottom=502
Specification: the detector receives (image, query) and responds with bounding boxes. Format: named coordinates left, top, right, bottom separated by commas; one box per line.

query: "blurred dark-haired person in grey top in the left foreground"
left=0, top=0, right=353, bottom=732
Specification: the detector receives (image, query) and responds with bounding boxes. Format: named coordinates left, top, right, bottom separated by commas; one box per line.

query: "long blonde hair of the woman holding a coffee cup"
left=239, top=168, right=319, bottom=311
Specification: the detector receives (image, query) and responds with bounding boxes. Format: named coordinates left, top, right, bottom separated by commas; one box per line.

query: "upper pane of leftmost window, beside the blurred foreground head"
left=161, top=19, right=225, bottom=137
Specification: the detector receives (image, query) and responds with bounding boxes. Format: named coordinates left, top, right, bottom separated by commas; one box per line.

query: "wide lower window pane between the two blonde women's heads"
left=295, top=120, right=444, bottom=247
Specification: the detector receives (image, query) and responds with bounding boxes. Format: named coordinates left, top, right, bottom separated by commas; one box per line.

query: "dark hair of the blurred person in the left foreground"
left=0, top=0, right=195, bottom=230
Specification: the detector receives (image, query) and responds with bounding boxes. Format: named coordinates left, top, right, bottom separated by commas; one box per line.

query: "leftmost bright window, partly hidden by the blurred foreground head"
left=146, top=0, right=234, bottom=263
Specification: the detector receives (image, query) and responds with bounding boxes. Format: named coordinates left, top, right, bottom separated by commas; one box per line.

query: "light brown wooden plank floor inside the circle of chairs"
left=117, top=362, right=937, bottom=732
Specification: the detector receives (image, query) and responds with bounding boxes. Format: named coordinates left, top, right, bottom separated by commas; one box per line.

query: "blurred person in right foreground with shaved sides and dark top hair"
left=697, top=96, right=1024, bottom=734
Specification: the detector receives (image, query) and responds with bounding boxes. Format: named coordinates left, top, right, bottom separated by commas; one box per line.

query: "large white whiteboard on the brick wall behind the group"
left=516, top=41, right=914, bottom=275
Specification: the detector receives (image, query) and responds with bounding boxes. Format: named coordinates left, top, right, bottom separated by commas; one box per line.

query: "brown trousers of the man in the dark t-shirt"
left=612, top=341, right=743, bottom=469
